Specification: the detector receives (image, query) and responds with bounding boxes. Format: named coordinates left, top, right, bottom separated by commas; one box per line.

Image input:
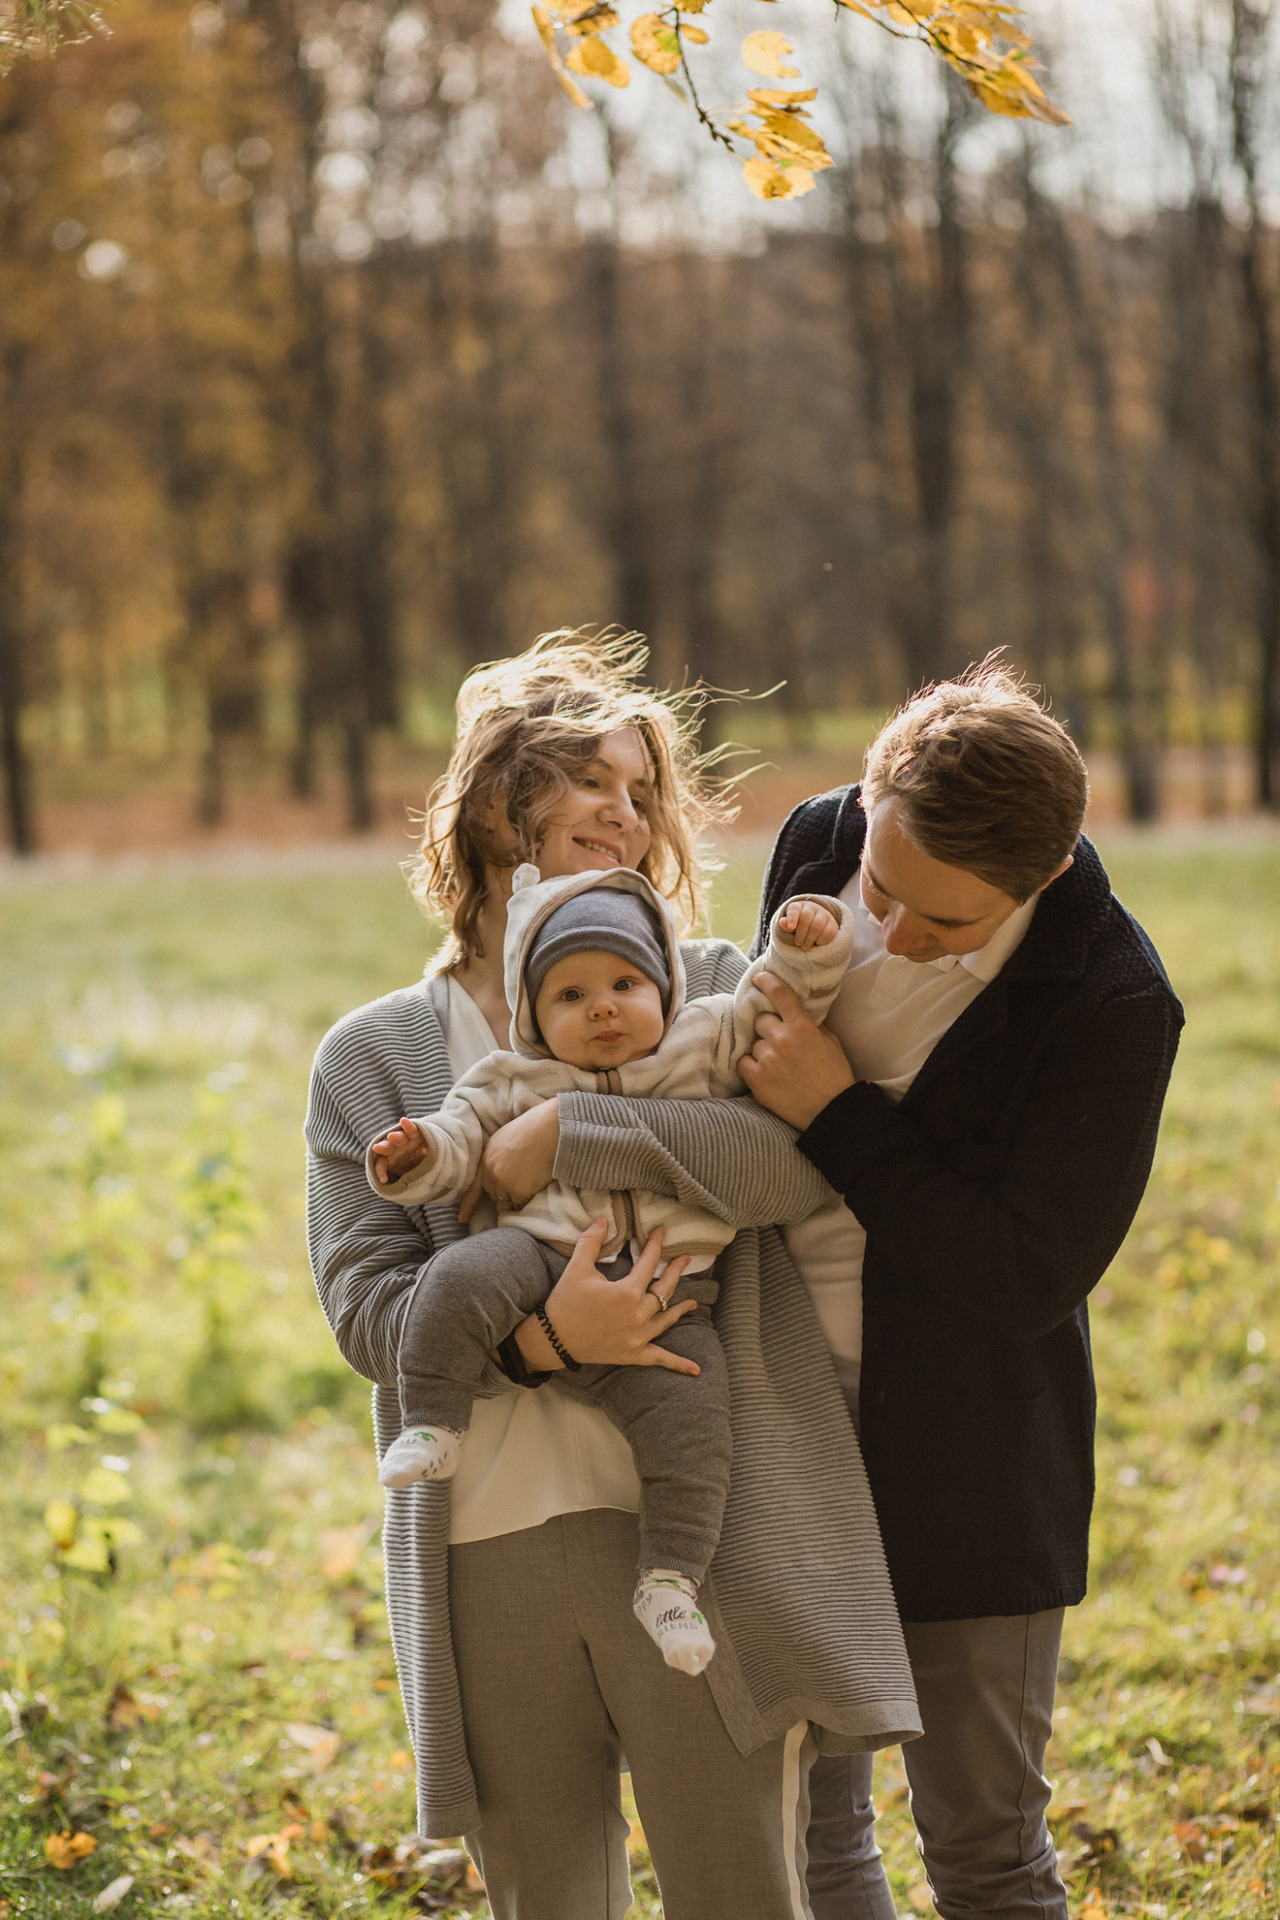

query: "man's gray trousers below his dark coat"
left=808, top=1607, right=1067, bottom=1920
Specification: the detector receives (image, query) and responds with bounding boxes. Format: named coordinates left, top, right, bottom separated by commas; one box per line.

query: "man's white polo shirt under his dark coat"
left=785, top=874, right=1038, bottom=1394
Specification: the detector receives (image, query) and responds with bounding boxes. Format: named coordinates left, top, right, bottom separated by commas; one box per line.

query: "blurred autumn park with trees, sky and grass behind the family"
left=0, top=0, right=1280, bottom=1920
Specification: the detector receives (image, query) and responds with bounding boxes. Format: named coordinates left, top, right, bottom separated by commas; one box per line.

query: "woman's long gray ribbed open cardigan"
left=305, top=941, right=919, bottom=1837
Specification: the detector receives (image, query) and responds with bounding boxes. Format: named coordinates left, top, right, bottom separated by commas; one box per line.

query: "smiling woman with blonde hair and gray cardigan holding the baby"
left=307, top=636, right=919, bottom=1920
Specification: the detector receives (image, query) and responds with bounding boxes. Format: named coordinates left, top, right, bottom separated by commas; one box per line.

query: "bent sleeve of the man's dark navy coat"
left=798, top=991, right=1180, bottom=1340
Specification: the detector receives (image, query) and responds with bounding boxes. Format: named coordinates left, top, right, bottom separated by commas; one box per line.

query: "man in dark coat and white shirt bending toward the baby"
left=743, top=664, right=1182, bottom=1920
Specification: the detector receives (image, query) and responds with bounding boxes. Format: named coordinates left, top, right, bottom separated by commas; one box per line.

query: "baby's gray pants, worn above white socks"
left=399, top=1227, right=731, bottom=1580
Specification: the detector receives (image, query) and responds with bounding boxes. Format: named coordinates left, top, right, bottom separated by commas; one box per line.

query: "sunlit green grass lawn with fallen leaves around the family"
left=0, top=837, right=1280, bottom=1920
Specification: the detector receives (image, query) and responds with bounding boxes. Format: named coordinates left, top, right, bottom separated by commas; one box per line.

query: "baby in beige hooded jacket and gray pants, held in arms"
left=367, top=866, right=852, bottom=1674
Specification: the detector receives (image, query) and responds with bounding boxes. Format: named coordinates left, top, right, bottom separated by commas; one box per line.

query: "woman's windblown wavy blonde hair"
left=409, top=628, right=731, bottom=970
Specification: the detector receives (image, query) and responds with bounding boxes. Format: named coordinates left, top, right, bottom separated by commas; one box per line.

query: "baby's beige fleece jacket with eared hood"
left=365, top=866, right=854, bottom=1265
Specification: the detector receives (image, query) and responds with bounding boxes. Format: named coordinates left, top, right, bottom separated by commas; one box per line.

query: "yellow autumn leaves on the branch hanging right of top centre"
left=533, top=0, right=1067, bottom=200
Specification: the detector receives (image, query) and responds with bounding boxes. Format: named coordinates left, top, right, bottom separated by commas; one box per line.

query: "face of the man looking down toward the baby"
left=862, top=801, right=1019, bottom=962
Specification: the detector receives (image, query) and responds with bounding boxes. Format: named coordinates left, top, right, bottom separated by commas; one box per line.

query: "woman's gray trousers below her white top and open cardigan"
left=449, top=1507, right=814, bottom=1920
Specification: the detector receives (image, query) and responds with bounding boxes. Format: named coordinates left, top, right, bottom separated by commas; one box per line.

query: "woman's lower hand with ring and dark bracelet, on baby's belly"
left=516, top=1219, right=700, bottom=1373
